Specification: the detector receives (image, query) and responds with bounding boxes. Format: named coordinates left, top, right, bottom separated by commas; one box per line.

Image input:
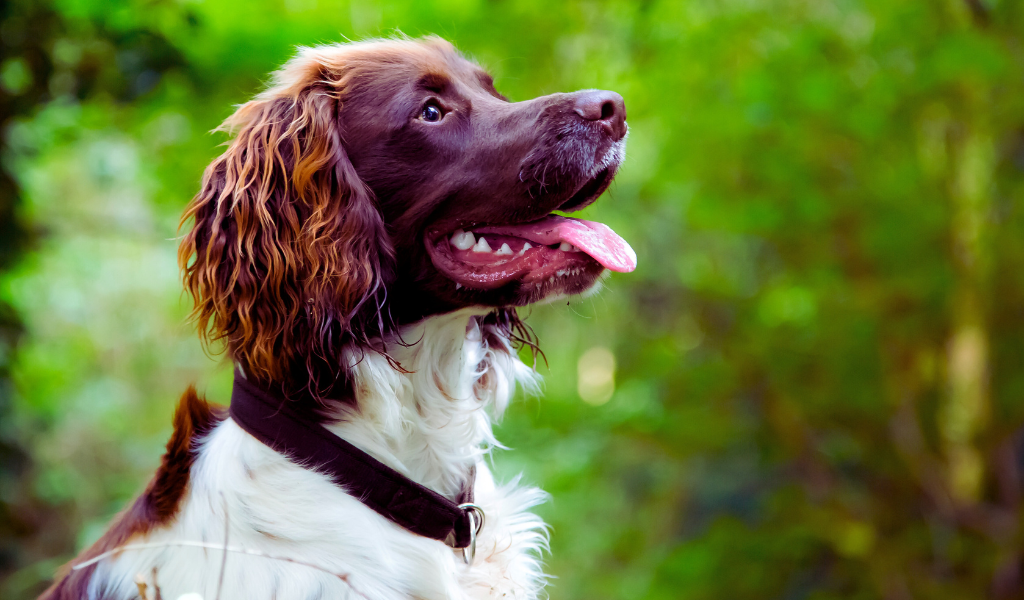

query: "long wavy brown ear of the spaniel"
left=178, top=54, right=392, bottom=395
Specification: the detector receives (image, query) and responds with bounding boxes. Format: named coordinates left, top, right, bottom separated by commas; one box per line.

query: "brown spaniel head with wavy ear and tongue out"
left=179, top=38, right=635, bottom=393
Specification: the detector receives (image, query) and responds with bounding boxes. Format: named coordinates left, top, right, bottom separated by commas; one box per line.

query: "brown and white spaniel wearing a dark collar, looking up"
left=42, top=38, right=636, bottom=600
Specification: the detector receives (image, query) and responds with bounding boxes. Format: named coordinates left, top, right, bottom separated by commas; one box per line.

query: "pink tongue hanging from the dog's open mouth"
left=491, top=215, right=637, bottom=273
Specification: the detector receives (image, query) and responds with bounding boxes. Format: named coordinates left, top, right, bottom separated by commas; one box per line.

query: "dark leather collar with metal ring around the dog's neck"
left=229, top=370, right=475, bottom=548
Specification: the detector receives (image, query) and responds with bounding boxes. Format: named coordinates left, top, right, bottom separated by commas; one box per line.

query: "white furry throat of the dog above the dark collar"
left=326, top=309, right=537, bottom=499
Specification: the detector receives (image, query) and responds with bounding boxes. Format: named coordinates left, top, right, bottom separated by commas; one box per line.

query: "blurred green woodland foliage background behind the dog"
left=0, top=0, right=1024, bottom=600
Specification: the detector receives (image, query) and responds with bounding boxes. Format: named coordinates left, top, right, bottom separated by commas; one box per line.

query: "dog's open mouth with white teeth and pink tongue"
left=427, top=215, right=637, bottom=290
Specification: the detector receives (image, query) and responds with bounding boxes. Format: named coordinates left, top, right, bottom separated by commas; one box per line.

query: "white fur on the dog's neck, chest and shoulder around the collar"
left=90, top=310, right=547, bottom=600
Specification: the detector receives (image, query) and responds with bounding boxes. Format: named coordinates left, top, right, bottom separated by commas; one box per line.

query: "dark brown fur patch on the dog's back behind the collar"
left=40, top=386, right=226, bottom=600
